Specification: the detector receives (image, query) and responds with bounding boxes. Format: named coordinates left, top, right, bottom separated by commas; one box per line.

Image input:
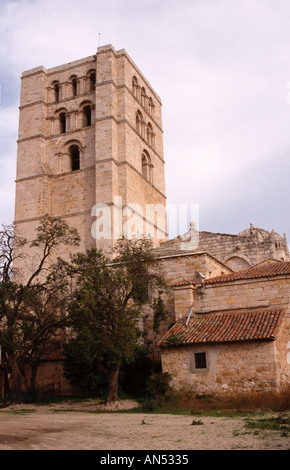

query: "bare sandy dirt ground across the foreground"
left=0, top=400, right=290, bottom=451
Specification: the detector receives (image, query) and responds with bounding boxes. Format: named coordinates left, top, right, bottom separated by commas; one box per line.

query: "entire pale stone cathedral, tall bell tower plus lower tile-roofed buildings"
left=8, top=45, right=290, bottom=395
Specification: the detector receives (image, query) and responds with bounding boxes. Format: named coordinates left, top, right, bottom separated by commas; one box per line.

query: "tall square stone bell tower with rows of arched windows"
left=15, top=45, right=166, bottom=256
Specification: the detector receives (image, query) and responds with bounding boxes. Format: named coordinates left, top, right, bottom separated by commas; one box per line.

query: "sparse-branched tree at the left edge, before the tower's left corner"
left=0, top=216, right=79, bottom=401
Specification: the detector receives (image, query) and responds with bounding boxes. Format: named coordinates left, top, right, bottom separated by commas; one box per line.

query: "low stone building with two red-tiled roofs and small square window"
left=158, top=261, right=290, bottom=394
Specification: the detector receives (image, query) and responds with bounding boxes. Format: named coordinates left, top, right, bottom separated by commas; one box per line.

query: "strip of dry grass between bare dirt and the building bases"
left=0, top=389, right=290, bottom=416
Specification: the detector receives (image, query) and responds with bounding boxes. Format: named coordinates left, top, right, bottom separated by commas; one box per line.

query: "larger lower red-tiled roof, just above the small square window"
left=158, top=310, right=284, bottom=347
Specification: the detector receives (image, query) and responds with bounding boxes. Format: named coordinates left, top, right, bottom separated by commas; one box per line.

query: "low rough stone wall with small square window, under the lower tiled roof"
left=162, top=342, right=280, bottom=394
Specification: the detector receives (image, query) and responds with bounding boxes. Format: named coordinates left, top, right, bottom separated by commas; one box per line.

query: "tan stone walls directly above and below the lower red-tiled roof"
left=162, top=275, right=290, bottom=393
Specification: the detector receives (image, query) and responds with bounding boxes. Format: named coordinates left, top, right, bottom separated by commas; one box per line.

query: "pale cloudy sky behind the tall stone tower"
left=0, top=0, right=290, bottom=243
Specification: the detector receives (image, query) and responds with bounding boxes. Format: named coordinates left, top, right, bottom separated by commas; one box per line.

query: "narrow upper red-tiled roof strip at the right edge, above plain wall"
left=204, top=261, right=290, bottom=284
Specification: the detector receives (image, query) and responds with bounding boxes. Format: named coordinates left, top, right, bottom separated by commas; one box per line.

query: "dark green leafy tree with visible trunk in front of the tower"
left=67, top=239, right=166, bottom=403
